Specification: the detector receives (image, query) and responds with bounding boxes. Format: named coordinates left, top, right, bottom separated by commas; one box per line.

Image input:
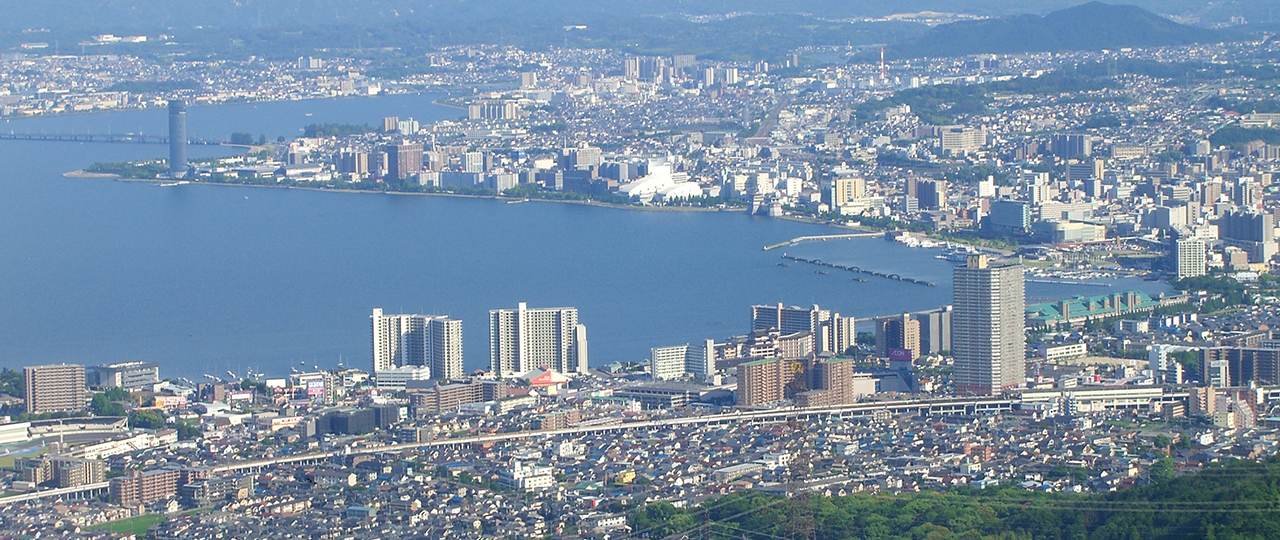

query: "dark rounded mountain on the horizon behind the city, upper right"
left=887, top=1, right=1228, bottom=58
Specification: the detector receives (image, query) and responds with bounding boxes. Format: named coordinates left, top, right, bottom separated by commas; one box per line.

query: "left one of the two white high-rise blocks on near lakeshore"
left=370, top=308, right=462, bottom=380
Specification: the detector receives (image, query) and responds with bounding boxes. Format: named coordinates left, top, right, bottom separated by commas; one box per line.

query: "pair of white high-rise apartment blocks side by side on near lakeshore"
left=371, top=302, right=588, bottom=386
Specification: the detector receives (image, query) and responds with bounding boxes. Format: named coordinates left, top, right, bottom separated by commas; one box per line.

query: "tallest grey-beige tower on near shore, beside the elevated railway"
left=951, top=255, right=1027, bottom=395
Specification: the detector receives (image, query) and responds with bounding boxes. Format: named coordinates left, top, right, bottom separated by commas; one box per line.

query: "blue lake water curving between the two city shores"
left=0, top=95, right=1164, bottom=377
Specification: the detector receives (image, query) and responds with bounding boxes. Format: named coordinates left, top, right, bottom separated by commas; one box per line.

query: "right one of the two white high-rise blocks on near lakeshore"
left=489, top=302, right=588, bottom=377
